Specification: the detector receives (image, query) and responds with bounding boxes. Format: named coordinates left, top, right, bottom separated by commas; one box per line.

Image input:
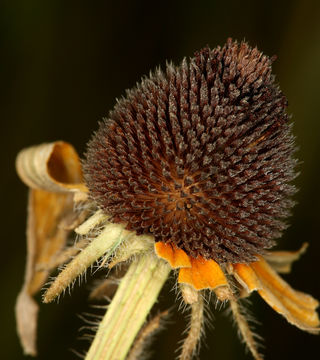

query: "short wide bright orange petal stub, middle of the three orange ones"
left=178, top=257, right=229, bottom=290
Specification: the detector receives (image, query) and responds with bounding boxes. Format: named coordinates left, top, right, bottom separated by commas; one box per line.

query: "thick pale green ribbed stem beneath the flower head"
left=86, top=253, right=170, bottom=360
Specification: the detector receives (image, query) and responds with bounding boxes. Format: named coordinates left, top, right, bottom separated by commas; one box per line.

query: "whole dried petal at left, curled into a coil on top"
left=16, top=141, right=86, bottom=355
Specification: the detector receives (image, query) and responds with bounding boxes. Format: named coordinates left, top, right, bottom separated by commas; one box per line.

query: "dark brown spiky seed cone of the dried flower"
left=84, top=39, right=296, bottom=263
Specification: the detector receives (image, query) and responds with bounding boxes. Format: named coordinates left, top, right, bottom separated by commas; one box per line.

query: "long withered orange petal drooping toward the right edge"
left=233, top=256, right=320, bottom=333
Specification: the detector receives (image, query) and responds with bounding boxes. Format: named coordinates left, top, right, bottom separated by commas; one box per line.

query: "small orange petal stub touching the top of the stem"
left=154, top=241, right=191, bottom=269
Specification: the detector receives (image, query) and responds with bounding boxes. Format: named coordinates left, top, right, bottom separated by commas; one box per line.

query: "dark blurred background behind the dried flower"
left=0, top=0, right=320, bottom=360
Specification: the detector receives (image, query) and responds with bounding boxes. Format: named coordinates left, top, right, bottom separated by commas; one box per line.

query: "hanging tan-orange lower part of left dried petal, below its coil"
left=16, top=190, right=73, bottom=355
